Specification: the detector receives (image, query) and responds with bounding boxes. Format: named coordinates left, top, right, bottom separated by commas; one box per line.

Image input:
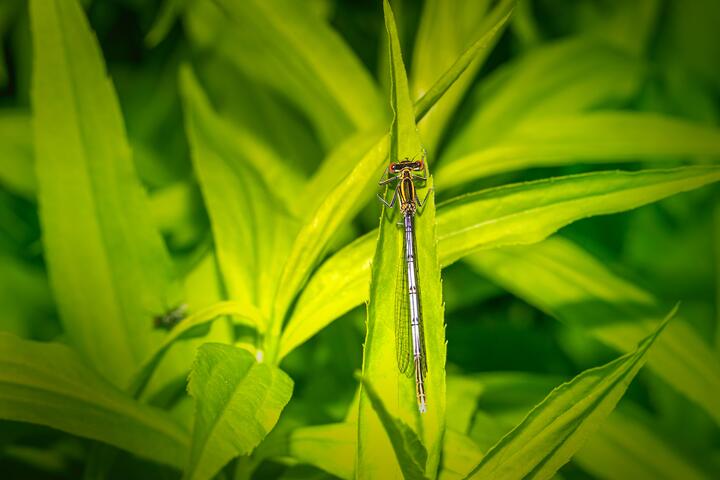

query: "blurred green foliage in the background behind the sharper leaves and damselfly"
left=0, top=0, right=720, bottom=479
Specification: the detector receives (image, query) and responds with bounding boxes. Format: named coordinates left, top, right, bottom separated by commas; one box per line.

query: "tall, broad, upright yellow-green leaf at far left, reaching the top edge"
left=30, top=0, right=179, bottom=385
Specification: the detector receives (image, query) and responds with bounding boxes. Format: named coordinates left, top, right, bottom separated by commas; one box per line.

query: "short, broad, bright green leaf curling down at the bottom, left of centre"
left=184, top=343, right=293, bottom=479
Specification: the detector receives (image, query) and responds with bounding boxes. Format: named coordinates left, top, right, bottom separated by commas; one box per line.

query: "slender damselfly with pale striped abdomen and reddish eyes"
left=378, top=156, right=431, bottom=413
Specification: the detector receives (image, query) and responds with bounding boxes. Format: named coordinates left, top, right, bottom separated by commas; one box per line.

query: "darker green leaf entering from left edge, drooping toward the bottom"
left=0, top=333, right=189, bottom=468
